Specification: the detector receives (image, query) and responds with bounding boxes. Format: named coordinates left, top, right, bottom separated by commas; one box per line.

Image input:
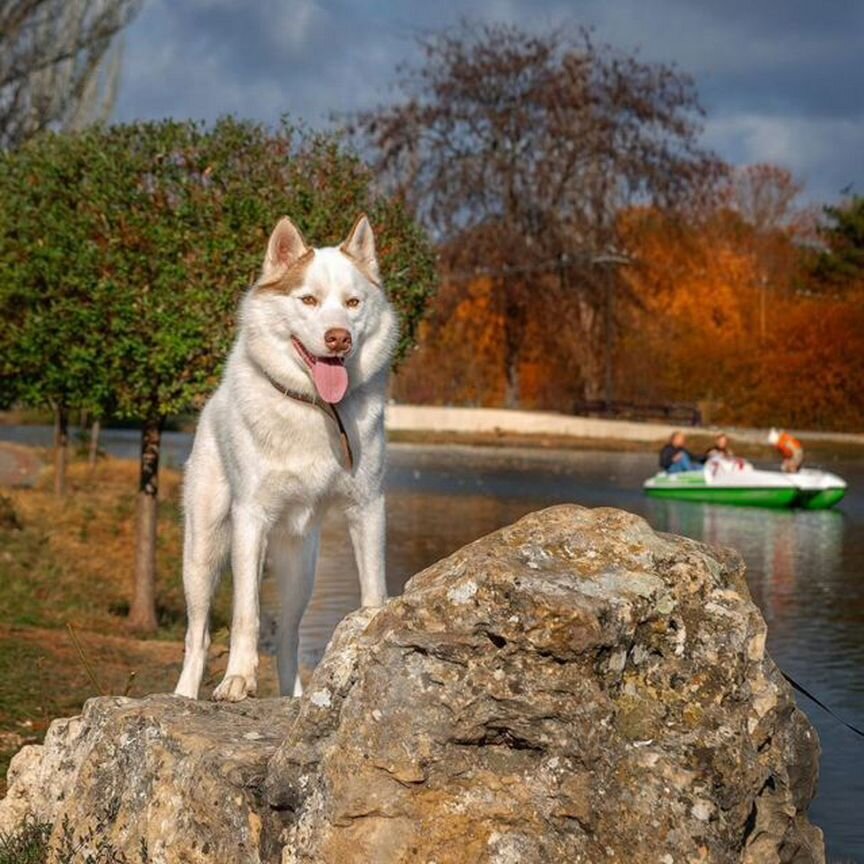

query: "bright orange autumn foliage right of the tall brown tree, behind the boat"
left=617, top=207, right=864, bottom=430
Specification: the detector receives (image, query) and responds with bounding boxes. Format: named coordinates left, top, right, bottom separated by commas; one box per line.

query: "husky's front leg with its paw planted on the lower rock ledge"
left=213, top=507, right=268, bottom=702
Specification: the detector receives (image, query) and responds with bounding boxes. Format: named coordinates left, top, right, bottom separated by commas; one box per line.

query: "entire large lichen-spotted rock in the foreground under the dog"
left=0, top=506, right=824, bottom=864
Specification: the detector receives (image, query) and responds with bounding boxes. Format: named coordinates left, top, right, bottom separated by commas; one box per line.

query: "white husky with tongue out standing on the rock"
left=175, top=216, right=398, bottom=702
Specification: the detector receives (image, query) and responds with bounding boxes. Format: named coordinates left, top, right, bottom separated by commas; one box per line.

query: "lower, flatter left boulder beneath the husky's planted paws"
left=0, top=696, right=298, bottom=864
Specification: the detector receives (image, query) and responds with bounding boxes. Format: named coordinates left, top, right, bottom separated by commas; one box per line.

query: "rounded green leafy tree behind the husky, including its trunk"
left=0, top=119, right=434, bottom=631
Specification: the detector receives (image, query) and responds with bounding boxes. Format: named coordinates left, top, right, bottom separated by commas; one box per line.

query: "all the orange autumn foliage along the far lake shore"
left=393, top=180, right=864, bottom=431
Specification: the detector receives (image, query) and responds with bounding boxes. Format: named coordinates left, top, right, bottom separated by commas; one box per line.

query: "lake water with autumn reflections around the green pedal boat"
left=0, top=428, right=864, bottom=864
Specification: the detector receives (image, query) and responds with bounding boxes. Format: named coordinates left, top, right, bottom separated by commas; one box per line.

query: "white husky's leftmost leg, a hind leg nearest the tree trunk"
left=174, top=475, right=231, bottom=699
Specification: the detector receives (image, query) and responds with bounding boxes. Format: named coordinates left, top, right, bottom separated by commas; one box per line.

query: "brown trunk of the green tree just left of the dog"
left=129, top=418, right=162, bottom=633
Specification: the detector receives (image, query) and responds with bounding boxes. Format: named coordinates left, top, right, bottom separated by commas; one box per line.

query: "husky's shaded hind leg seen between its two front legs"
left=270, top=527, right=319, bottom=696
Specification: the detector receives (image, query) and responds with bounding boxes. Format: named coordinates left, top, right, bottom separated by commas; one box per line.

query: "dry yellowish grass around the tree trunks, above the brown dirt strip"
left=0, top=459, right=192, bottom=638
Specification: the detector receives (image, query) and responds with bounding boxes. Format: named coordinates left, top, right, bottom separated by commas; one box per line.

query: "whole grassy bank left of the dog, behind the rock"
left=0, top=459, right=273, bottom=794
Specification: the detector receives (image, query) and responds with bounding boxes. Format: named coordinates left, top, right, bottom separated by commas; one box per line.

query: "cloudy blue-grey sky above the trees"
left=115, top=0, right=864, bottom=202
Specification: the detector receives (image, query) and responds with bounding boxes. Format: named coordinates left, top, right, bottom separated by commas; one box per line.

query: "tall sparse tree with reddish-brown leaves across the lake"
left=354, top=22, right=723, bottom=404
